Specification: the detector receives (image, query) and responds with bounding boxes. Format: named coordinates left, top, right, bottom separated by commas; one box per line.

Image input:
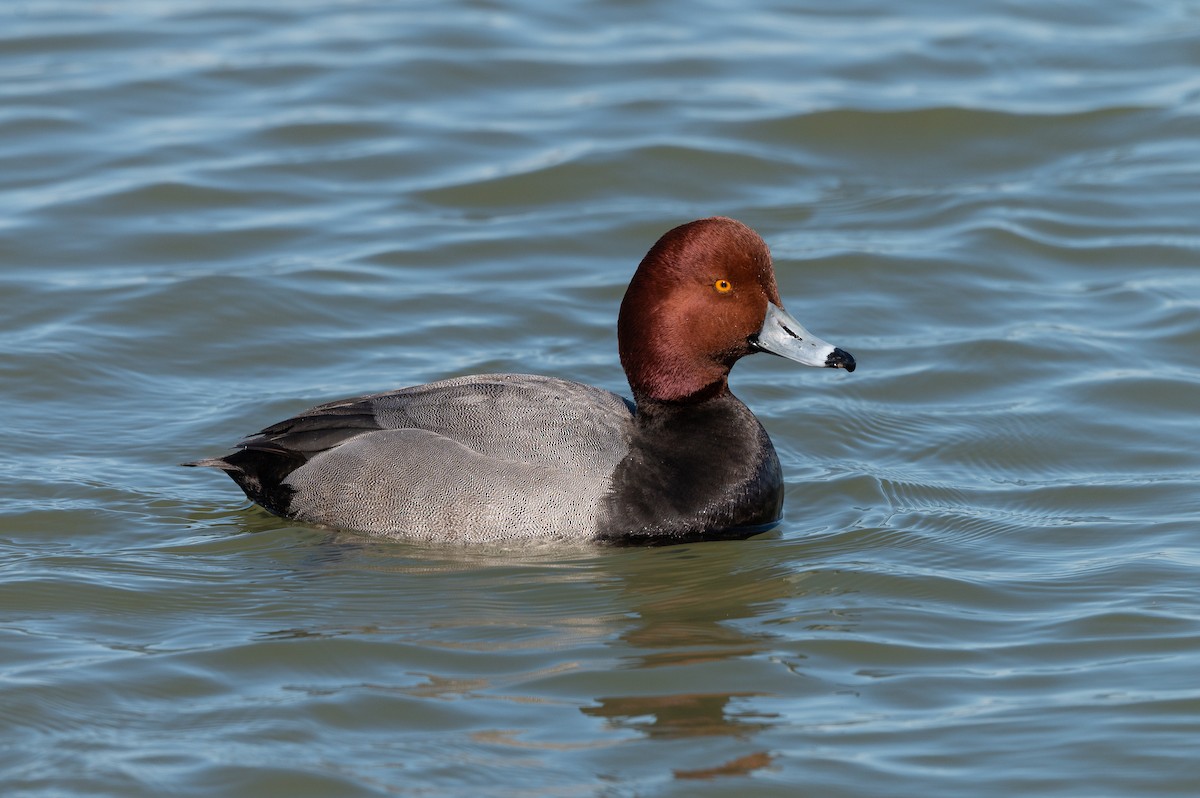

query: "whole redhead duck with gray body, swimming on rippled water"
left=185, top=217, right=854, bottom=544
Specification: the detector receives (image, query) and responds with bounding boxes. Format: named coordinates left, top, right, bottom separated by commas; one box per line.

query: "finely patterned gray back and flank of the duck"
left=286, top=374, right=632, bottom=541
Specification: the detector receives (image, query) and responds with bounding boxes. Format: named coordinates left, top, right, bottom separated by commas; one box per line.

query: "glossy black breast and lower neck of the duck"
left=601, top=391, right=784, bottom=544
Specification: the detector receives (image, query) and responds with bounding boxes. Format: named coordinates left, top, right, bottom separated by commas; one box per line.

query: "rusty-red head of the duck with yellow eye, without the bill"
left=617, top=217, right=780, bottom=401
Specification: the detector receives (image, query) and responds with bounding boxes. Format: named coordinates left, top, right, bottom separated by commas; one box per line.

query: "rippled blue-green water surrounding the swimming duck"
left=0, top=0, right=1200, bottom=798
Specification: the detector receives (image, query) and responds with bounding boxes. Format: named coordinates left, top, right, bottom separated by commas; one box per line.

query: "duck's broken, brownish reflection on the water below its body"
left=266, top=534, right=830, bottom=753
